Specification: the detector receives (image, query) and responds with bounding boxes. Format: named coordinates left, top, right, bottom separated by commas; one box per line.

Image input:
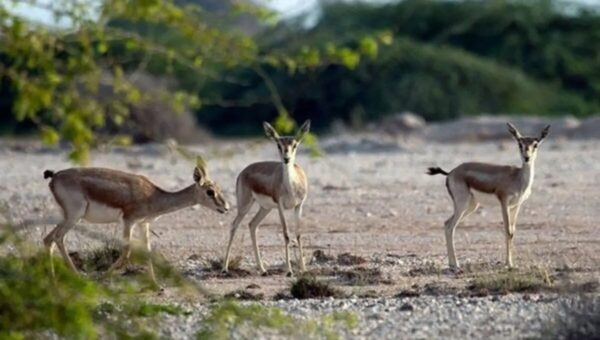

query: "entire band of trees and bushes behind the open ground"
left=0, top=0, right=600, bottom=154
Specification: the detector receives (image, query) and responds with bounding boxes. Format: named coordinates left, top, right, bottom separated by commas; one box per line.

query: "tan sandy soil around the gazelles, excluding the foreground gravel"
left=0, top=135, right=600, bottom=297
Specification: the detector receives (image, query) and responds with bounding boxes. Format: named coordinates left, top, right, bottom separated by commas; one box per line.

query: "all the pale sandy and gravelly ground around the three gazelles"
left=0, top=121, right=600, bottom=338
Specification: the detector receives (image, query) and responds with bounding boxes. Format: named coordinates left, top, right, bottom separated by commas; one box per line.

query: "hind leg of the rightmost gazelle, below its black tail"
left=444, top=178, right=477, bottom=269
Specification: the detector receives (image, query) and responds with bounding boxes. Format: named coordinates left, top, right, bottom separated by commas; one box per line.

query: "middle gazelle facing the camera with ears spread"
left=223, top=121, right=310, bottom=276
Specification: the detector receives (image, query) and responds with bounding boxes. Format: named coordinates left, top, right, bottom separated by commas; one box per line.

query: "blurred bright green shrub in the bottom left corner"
left=0, top=254, right=103, bottom=338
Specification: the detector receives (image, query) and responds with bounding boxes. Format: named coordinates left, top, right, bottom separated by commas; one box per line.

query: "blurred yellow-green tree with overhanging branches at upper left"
left=0, top=0, right=384, bottom=162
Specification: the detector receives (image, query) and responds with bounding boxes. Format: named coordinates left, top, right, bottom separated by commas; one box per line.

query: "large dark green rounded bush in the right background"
left=198, top=0, right=600, bottom=133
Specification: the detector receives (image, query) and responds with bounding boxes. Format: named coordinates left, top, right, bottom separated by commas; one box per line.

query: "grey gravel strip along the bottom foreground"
left=154, top=294, right=592, bottom=339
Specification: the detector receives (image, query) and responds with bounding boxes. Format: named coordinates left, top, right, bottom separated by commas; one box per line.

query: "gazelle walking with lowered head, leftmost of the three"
left=44, top=159, right=229, bottom=283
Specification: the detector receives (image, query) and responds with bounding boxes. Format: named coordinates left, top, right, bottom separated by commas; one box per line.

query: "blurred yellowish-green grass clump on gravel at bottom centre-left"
left=197, top=301, right=358, bottom=339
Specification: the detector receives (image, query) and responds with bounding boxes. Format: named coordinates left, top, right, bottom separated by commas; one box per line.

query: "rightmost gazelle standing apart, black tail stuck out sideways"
left=428, top=123, right=550, bottom=269
